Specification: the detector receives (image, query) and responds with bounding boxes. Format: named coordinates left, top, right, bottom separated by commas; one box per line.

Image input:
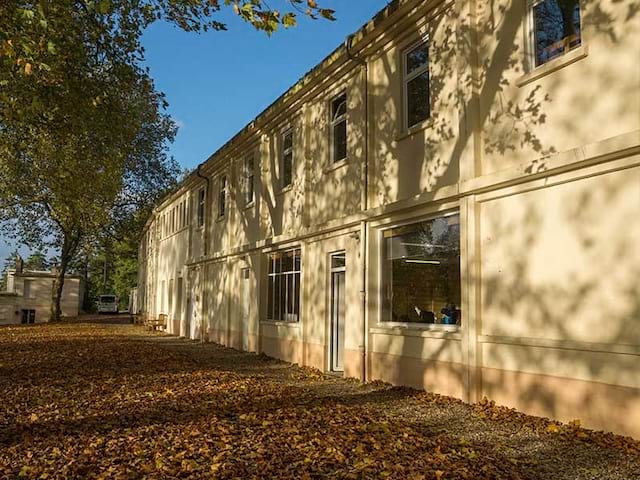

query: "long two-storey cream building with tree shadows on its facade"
left=138, top=0, right=640, bottom=437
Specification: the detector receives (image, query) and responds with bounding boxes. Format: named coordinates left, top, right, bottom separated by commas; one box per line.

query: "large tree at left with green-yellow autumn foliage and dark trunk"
left=0, top=0, right=333, bottom=319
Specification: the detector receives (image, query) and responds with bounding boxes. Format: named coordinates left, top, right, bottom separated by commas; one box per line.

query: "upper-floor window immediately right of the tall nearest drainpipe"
left=404, top=41, right=431, bottom=128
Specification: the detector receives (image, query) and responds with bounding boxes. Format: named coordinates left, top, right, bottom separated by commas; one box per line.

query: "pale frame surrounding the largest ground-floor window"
left=376, top=207, right=468, bottom=334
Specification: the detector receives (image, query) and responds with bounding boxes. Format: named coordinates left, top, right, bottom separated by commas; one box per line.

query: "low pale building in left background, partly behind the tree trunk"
left=0, top=259, right=84, bottom=325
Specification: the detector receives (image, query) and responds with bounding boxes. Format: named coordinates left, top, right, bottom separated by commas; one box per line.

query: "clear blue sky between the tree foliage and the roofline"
left=0, top=0, right=387, bottom=262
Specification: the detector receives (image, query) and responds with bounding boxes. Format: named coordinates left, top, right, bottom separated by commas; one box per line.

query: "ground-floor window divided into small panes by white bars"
left=267, top=249, right=302, bottom=322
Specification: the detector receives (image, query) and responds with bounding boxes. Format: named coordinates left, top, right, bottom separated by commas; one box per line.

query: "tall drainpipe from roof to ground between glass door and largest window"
left=344, top=34, right=369, bottom=383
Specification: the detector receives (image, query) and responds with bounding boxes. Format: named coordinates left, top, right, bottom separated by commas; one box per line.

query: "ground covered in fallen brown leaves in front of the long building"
left=0, top=324, right=640, bottom=480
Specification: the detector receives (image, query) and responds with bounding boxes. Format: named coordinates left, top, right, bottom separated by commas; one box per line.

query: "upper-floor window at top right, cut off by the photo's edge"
left=529, top=0, right=582, bottom=67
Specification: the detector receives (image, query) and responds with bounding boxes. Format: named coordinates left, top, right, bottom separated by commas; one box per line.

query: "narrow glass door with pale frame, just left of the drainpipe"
left=330, top=252, right=346, bottom=372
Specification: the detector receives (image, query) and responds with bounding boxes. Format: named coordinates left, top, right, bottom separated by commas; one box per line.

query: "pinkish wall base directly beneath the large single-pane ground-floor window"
left=369, top=353, right=464, bottom=398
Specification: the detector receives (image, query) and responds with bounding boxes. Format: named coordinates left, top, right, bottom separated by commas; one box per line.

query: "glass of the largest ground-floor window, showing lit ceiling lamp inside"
left=382, top=214, right=462, bottom=325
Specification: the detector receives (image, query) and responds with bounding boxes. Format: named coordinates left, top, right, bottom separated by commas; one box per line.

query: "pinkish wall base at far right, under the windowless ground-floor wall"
left=482, top=368, right=640, bottom=438
